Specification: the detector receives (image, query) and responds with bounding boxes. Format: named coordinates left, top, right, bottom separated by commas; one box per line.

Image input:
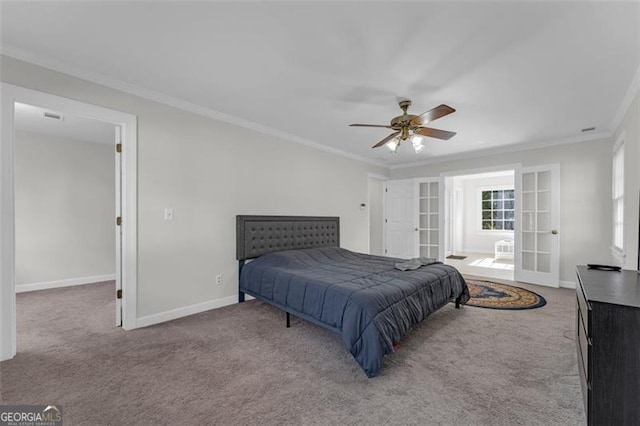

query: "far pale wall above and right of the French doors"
left=391, top=139, right=616, bottom=282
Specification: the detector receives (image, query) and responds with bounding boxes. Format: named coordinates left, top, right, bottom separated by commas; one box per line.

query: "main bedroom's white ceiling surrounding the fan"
left=0, top=1, right=640, bottom=166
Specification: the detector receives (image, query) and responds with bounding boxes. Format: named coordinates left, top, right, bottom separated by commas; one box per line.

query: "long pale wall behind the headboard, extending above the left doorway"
left=0, top=56, right=388, bottom=323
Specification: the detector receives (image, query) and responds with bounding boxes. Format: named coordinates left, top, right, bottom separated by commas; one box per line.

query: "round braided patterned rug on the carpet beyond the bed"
left=466, top=279, right=547, bottom=310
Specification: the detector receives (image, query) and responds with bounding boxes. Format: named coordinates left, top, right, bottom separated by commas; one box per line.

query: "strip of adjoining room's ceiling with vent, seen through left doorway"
left=14, top=102, right=115, bottom=144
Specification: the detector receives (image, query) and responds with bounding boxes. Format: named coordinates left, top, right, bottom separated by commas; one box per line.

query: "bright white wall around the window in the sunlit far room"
left=455, top=176, right=514, bottom=254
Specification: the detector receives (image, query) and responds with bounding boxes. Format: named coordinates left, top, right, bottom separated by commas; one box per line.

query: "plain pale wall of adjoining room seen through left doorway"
left=15, top=131, right=115, bottom=291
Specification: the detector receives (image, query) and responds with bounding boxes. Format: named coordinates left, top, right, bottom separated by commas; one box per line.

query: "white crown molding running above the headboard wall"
left=0, top=45, right=389, bottom=169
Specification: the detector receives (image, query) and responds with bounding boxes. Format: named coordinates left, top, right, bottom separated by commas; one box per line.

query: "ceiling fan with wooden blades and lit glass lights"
left=349, top=99, right=456, bottom=153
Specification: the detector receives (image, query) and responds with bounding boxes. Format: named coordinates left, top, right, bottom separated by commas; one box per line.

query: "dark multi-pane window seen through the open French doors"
left=480, top=188, right=515, bottom=231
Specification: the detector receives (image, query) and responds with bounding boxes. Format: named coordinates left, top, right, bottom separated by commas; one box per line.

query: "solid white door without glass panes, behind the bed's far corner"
left=385, top=179, right=417, bottom=259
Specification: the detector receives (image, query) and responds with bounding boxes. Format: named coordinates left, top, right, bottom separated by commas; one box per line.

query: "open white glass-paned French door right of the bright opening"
left=515, top=164, right=560, bottom=287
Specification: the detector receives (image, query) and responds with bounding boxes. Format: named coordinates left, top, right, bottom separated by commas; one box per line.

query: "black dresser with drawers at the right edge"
left=576, top=266, right=640, bottom=426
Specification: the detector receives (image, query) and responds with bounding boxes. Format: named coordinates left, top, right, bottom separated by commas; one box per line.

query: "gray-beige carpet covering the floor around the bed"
left=0, top=283, right=584, bottom=426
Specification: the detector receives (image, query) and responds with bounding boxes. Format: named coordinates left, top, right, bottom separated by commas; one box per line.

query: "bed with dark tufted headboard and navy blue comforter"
left=236, top=216, right=469, bottom=377
